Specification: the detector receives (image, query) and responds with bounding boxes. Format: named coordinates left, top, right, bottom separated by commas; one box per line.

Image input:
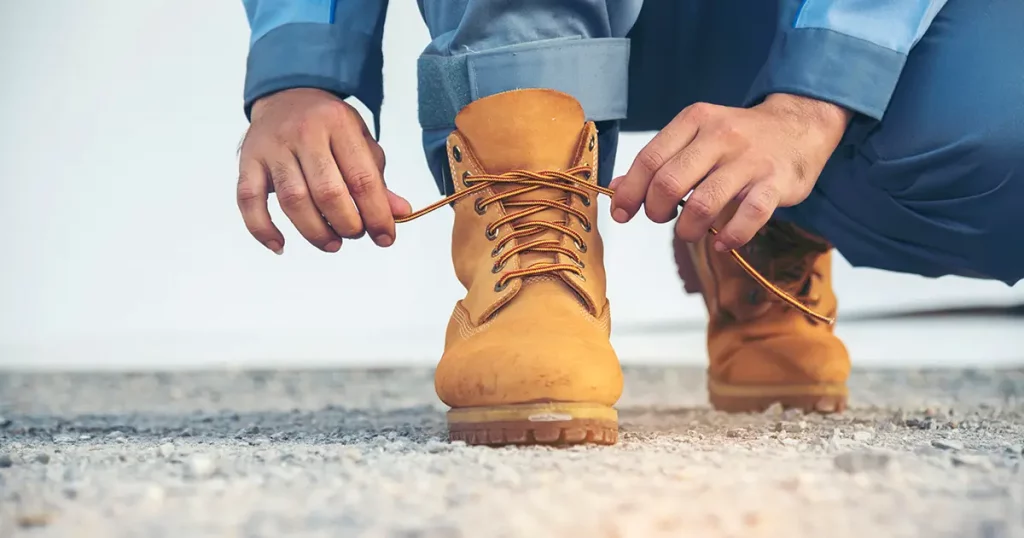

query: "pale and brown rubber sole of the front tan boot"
left=447, top=402, right=618, bottom=446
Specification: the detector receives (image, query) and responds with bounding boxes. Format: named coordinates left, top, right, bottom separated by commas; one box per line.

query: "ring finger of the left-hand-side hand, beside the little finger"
left=267, top=148, right=341, bottom=252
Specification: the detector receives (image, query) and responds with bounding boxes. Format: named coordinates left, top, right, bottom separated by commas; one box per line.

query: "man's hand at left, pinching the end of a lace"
left=238, top=88, right=412, bottom=254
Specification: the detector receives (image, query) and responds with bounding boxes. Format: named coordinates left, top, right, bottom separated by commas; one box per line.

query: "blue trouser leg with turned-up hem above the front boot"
left=419, top=0, right=642, bottom=194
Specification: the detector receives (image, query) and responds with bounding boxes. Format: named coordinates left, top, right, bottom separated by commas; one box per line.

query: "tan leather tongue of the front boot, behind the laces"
left=455, top=89, right=586, bottom=284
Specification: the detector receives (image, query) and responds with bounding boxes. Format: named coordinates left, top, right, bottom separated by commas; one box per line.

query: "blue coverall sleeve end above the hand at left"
left=243, top=0, right=387, bottom=127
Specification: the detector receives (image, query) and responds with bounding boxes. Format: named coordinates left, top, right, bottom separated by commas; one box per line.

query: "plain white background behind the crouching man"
left=0, top=0, right=1024, bottom=368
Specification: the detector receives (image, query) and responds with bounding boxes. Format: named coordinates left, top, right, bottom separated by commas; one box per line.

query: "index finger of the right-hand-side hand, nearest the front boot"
left=611, top=104, right=712, bottom=222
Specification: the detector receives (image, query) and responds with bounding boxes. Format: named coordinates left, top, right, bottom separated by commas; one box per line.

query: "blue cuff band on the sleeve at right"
left=748, top=28, right=906, bottom=120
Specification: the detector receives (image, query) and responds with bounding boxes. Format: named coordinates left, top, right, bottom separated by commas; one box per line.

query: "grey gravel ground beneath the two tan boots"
left=0, top=368, right=1024, bottom=538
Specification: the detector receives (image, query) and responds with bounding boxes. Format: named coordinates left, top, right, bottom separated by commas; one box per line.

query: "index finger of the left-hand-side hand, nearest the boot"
left=331, top=129, right=395, bottom=247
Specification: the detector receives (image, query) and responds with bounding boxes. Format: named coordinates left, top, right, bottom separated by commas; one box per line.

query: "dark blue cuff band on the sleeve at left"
left=244, top=23, right=383, bottom=124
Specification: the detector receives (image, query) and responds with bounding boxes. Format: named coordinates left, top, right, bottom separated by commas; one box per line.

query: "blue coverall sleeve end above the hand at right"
left=748, top=0, right=946, bottom=120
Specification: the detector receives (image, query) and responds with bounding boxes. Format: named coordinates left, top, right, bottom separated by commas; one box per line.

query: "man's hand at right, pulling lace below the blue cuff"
left=611, top=93, right=851, bottom=251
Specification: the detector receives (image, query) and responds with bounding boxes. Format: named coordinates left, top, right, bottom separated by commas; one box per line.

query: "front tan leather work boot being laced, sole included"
left=434, top=89, right=623, bottom=445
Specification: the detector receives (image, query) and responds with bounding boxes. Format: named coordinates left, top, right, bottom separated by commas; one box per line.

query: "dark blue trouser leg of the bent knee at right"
left=780, top=0, right=1024, bottom=285
